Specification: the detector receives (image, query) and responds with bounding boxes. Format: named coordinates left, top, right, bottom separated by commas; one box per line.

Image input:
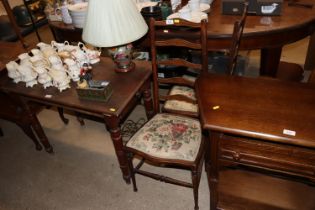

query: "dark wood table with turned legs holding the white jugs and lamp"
left=0, top=58, right=153, bottom=182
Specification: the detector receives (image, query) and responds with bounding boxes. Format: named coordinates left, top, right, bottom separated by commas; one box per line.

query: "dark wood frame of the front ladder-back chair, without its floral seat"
left=124, top=18, right=208, bottom=210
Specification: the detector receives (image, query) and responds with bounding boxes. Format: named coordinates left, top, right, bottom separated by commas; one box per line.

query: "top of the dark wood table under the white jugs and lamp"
left=0, top=58, right=151, bottom=116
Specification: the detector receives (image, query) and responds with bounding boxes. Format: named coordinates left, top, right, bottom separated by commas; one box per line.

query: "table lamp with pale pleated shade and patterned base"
left=82, top=0, right=148, bottom=72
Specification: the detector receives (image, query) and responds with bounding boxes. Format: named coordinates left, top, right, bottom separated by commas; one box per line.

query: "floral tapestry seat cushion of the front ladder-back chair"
left=126, top=114, right=202, bottom=161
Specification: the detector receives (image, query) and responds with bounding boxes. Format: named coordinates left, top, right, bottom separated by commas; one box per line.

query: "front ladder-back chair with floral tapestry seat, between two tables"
left=124, top=19, right=207, bottom=210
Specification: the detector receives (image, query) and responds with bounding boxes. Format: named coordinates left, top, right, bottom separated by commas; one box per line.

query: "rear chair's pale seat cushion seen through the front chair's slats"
left=164, top=85, right=198, bottom=113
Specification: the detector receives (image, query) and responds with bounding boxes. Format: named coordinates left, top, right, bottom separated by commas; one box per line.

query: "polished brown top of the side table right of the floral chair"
left=196, top=74, right=315, bottom=148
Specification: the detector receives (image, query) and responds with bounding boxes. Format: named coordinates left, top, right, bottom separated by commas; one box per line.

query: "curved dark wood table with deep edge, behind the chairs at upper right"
left=196, top=0, right=315, bottom=50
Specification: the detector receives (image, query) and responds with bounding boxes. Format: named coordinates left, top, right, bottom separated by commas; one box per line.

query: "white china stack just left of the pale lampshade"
left=68, top=2, right=88, bottom=28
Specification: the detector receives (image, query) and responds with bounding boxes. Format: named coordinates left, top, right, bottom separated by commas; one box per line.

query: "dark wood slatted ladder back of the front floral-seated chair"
left=150, top=19, right=208, bottom=117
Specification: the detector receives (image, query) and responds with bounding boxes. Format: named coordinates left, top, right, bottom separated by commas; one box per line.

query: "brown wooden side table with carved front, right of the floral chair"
left=196, top=74, right=315, bottom=210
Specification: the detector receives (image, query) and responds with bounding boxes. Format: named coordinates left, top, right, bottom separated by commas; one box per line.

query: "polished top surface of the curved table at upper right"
left=208, top=0, right=315, bottom=36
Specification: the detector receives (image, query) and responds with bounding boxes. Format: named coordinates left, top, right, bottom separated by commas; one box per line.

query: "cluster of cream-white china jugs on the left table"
left=6, top=41, right=100, bottom=92
